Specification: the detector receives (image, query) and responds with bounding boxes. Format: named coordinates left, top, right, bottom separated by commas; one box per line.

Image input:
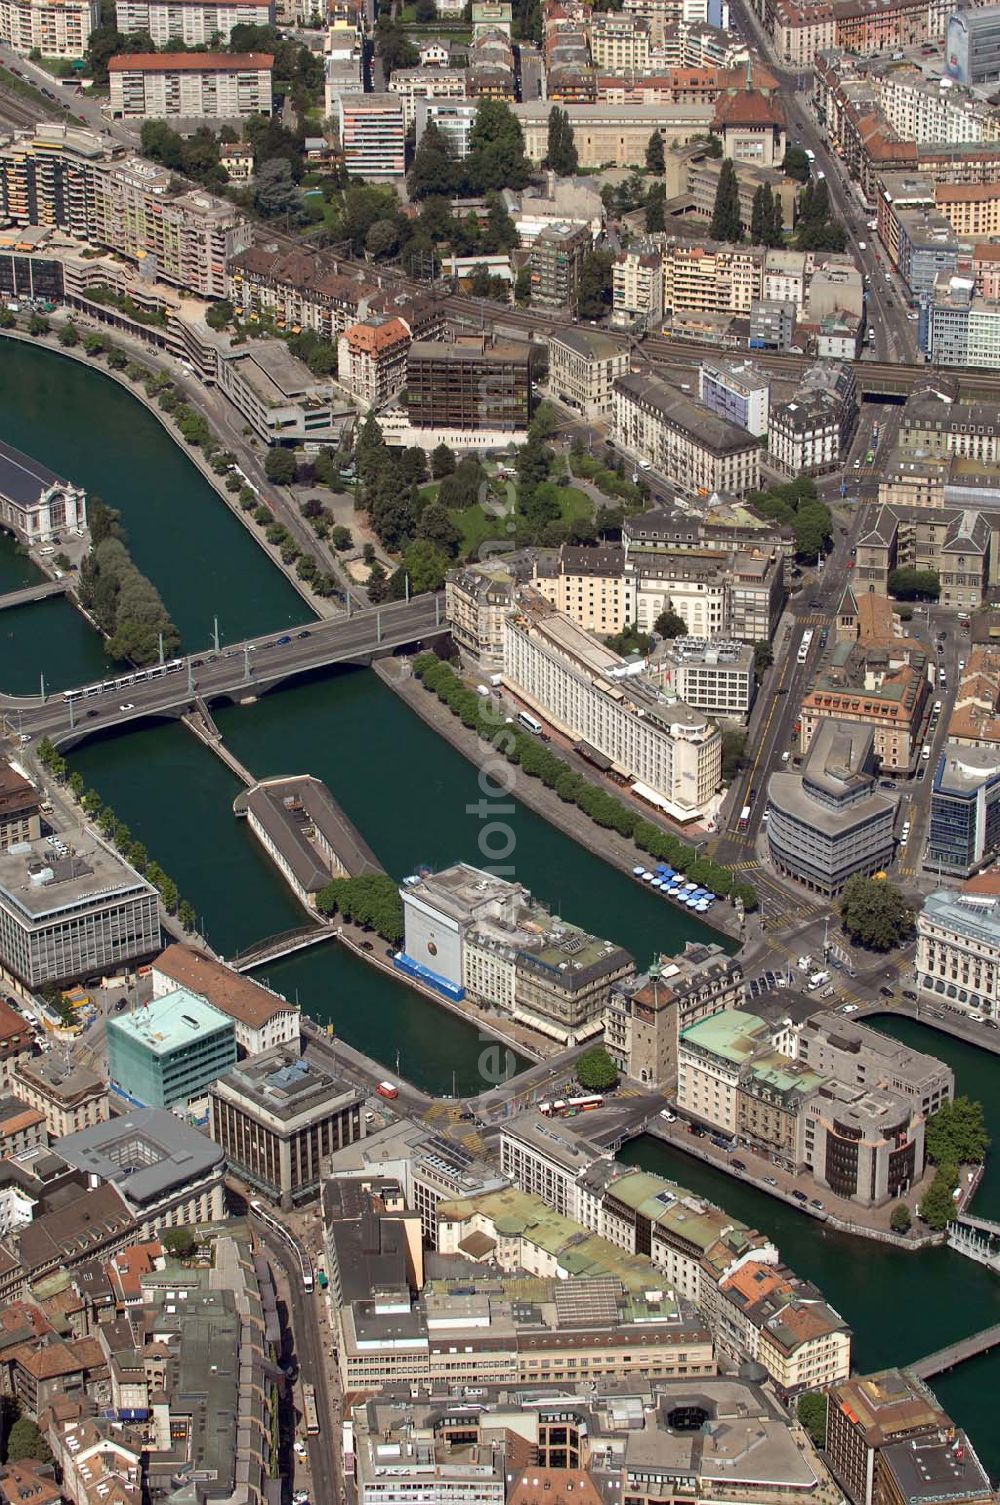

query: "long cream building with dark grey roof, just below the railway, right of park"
left=611, top=375, right=761, bottom=497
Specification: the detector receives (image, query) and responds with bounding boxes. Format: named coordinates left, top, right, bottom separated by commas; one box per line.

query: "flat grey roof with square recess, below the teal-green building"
left=59, top=1108, right=224, bottom=1207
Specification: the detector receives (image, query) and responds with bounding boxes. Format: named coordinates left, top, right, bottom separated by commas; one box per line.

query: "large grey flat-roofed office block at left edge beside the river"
left=0, top=831, right=160, bottom=990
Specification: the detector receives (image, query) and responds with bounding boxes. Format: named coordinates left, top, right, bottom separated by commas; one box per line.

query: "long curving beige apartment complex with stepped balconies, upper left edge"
left=0, top=128, right=250, bottom=299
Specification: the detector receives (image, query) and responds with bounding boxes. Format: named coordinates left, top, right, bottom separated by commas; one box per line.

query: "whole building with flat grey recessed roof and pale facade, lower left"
left=59, top=1108, right=224, bottom=1239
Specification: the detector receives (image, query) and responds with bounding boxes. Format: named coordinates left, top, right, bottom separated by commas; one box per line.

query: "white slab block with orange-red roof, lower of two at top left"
left=108, top=53, right=274, bottom=120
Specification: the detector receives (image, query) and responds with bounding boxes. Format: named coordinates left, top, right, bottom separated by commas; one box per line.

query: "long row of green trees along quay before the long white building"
left=413, top=652, right=758, bottom=912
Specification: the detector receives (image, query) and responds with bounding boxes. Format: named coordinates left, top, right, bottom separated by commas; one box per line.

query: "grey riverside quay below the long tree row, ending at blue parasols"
left=379, top=658, right=741, bottom=950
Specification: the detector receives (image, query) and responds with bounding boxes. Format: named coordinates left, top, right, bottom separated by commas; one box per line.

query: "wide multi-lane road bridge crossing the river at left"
left=0, top=594, right=447, bottom=748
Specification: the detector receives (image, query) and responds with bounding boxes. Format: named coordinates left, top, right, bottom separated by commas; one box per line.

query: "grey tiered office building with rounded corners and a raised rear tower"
left=767, top=718, right=896, bottom=895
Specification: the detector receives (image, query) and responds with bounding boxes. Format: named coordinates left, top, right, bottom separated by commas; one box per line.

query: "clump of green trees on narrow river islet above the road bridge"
left=77, top=497, right=181, bottom=665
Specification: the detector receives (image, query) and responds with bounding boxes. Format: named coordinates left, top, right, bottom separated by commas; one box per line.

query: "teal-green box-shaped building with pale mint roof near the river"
left=105, top=987, right=236, bottom=1108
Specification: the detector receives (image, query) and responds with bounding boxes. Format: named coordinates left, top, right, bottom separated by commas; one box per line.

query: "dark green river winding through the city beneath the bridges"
left=0, top=342, right=1000, bottom=1478
